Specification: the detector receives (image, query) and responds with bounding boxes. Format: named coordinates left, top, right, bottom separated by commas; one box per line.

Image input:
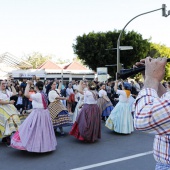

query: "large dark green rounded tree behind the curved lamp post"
left=73, top=30, right=150, bottom=76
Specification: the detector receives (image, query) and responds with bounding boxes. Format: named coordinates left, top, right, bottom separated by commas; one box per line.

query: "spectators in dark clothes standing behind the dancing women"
left=2, top=76, right=170, bottom=113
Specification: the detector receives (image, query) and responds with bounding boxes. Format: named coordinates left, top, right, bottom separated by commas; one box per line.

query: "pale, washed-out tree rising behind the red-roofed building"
left=26, top=52, right=52, bottom=69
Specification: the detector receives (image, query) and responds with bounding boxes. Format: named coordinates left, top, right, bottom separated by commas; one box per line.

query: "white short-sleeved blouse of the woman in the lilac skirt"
left=30, top=93, right=44, bottom=109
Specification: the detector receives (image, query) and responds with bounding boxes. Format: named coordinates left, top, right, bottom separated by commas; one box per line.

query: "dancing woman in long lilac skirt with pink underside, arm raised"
left=11, top=81, right=57, bottom=153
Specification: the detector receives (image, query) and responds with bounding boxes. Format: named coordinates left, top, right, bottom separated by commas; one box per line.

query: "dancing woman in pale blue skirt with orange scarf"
left=106, top=81, right=134, bottom=134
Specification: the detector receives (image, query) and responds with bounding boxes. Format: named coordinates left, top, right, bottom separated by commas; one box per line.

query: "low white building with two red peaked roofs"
left=12, top=60, right=95, bottom=82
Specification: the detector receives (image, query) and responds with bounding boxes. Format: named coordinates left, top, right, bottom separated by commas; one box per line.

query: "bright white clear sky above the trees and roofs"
left=0, top=0, right=170, bottom=59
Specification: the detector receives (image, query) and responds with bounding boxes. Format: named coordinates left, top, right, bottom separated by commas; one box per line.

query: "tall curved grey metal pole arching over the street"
left=116, top=4, right=170, bottom=80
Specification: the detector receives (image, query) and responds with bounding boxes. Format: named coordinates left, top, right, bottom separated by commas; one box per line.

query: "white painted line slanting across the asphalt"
left=71, top=151, right=153, bottom=170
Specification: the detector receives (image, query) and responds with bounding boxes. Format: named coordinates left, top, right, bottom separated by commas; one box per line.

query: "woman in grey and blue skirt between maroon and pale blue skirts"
left=97, top=83, right=113, bottom=121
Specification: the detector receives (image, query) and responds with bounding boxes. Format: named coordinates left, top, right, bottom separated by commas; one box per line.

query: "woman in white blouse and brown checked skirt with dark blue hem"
left=48, top=82, right=73, bottom=135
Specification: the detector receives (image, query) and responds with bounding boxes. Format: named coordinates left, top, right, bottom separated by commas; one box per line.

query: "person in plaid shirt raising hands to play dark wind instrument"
left=134, top=57, right=170, bottom=170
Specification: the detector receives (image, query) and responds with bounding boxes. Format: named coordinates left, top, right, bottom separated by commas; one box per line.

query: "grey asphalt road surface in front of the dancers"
left=0, top=122, right=155, bottom=170
